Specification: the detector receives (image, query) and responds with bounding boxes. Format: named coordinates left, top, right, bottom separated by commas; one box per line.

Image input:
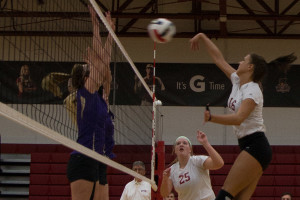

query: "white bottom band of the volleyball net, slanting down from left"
left=0, top=102, right=157, bottom=191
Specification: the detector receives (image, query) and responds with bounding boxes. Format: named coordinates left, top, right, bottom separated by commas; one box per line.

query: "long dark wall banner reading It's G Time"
left=0, top=62, right=300, bottom=107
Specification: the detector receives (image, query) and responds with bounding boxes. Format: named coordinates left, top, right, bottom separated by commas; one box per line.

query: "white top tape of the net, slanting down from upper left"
left=90, top=0, right=153, bottom=100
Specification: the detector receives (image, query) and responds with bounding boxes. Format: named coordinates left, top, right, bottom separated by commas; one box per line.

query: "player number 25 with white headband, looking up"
left=160, top=131, right=224, bottom=200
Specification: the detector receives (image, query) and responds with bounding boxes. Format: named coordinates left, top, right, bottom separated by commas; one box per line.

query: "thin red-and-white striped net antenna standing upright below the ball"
left=151, top=42, right=156, bottom=181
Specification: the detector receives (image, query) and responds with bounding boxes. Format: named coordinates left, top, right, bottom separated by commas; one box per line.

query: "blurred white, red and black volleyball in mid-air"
left=148, top=18, right=176, bottom=43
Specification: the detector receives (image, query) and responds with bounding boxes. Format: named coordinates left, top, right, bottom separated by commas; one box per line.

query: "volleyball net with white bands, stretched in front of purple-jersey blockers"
left=0, top=0, right=162, bottom=190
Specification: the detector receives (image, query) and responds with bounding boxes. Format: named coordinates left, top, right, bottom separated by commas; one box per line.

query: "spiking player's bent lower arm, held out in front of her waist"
left=204, top=98, right=256, bottom=125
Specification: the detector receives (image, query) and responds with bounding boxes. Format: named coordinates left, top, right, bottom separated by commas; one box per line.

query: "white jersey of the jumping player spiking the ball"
left=228, top=72, right=265, bottom=138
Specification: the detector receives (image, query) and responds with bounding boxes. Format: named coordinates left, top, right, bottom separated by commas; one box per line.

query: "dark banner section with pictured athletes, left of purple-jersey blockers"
left=0, top=62, right=74, bottom=104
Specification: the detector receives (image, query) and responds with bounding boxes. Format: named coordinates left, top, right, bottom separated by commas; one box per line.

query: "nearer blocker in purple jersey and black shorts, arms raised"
left=67, top=6, right=114, bottom=200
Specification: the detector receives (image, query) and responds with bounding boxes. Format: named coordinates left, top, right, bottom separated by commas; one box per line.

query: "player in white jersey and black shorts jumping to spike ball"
left=190, top=33, right=297, bottom=200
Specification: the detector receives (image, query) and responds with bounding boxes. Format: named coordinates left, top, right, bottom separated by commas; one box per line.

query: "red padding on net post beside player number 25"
left=155, top=141, right=166, bottom=200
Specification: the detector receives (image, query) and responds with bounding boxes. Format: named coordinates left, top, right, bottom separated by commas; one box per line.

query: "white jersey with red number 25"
left=170, top=156, right=215, bottom=200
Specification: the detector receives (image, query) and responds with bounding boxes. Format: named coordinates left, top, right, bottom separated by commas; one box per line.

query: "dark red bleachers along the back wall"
left=2, top=144, right=300, bottom=200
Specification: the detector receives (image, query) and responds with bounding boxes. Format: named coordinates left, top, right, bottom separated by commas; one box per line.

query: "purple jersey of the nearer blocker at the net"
left=73, top=87, right=107, bottom=154
